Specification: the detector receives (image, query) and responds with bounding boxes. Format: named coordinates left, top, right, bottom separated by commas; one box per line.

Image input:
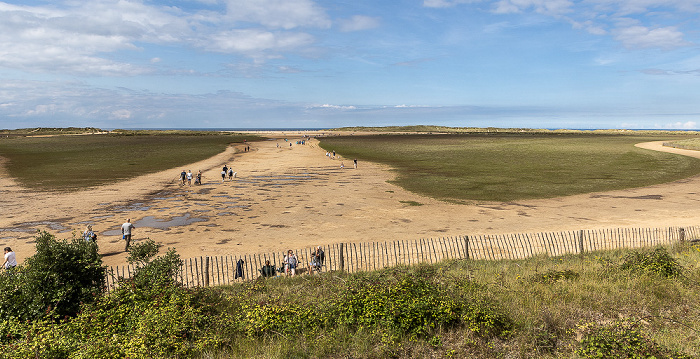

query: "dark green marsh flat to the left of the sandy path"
left=0, top=130, right=259, bottom=190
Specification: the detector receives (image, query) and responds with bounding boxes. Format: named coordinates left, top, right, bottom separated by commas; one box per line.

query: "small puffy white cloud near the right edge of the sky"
left=613, top=26, right=689, bottom=49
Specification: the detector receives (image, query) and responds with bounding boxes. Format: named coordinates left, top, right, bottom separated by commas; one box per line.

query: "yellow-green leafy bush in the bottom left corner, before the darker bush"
left=0, top=238, right=227, bottom=358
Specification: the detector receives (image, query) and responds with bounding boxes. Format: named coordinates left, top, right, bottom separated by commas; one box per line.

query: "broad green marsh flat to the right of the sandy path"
left=321, top=131, right=700, bottom=202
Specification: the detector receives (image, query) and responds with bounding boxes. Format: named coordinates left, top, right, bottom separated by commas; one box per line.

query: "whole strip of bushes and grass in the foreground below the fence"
left=0, top=233, right=700, bottom=358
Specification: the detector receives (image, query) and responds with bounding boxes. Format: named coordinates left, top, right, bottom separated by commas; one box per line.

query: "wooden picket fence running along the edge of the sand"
left=107, top=226, right=700, bottom=288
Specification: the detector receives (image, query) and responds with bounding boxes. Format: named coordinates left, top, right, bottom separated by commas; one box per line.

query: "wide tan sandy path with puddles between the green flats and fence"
left=0, top=138, right=700, bottom=265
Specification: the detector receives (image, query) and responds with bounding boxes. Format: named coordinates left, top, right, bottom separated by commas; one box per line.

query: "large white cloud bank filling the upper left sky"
left=0, top=0, right=334, bottom=76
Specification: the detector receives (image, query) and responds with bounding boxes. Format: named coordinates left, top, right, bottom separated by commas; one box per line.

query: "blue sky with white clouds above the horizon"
left=0, top=0, right=700, bottom=129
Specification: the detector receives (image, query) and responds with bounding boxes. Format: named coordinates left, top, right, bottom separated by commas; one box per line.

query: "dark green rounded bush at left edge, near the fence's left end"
left=0, top=232, right=105, bottom=320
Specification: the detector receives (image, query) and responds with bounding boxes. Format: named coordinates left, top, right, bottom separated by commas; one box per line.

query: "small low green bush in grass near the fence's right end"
left=620, top=247, right=684, bottom=278
